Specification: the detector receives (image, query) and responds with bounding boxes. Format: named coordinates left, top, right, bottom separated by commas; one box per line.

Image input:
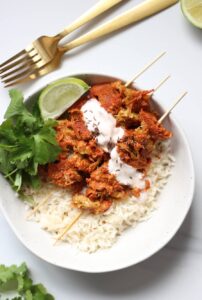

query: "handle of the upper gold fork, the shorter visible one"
left=57, top=0, right=124, bottom=39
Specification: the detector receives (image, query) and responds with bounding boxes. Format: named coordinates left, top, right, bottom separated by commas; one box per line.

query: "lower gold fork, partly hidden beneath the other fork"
left=0, top=0, right=178, bottom=87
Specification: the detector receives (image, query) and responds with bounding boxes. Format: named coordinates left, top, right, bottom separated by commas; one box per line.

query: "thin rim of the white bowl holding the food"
left=0, top=72, right=195, bottom=274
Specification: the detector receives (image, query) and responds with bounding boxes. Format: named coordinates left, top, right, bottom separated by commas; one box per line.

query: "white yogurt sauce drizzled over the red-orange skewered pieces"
left=81, top=98, right=145, bottom=189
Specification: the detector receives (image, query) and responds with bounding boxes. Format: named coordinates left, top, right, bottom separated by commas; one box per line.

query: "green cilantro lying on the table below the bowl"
left=0, top=263, right=54, bottom=300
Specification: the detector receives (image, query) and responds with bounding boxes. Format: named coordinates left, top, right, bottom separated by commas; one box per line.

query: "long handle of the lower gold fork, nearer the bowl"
left=60, top=0, right=178, bottom=52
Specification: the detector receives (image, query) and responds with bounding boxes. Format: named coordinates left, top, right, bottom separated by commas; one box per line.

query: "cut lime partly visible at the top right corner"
left=181, top=0, right=202, bottom=28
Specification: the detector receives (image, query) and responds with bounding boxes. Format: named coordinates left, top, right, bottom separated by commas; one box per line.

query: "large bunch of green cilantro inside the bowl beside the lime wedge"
left=0, top=89, right=61, bottom=191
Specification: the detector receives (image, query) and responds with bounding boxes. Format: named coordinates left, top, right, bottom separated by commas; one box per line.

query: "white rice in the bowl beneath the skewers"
left=24, top=142, right=174, bottom=253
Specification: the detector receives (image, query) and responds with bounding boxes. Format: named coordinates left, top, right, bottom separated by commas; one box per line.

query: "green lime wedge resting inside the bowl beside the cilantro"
left=39, top=77, right=89, bottom=119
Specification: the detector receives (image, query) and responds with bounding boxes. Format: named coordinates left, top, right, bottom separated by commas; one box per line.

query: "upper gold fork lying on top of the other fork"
left=0, top=0, right=123, bottom=84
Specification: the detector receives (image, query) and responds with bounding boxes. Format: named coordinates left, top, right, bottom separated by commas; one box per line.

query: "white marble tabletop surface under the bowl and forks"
left=0, top=0, right=202, bottom=300
